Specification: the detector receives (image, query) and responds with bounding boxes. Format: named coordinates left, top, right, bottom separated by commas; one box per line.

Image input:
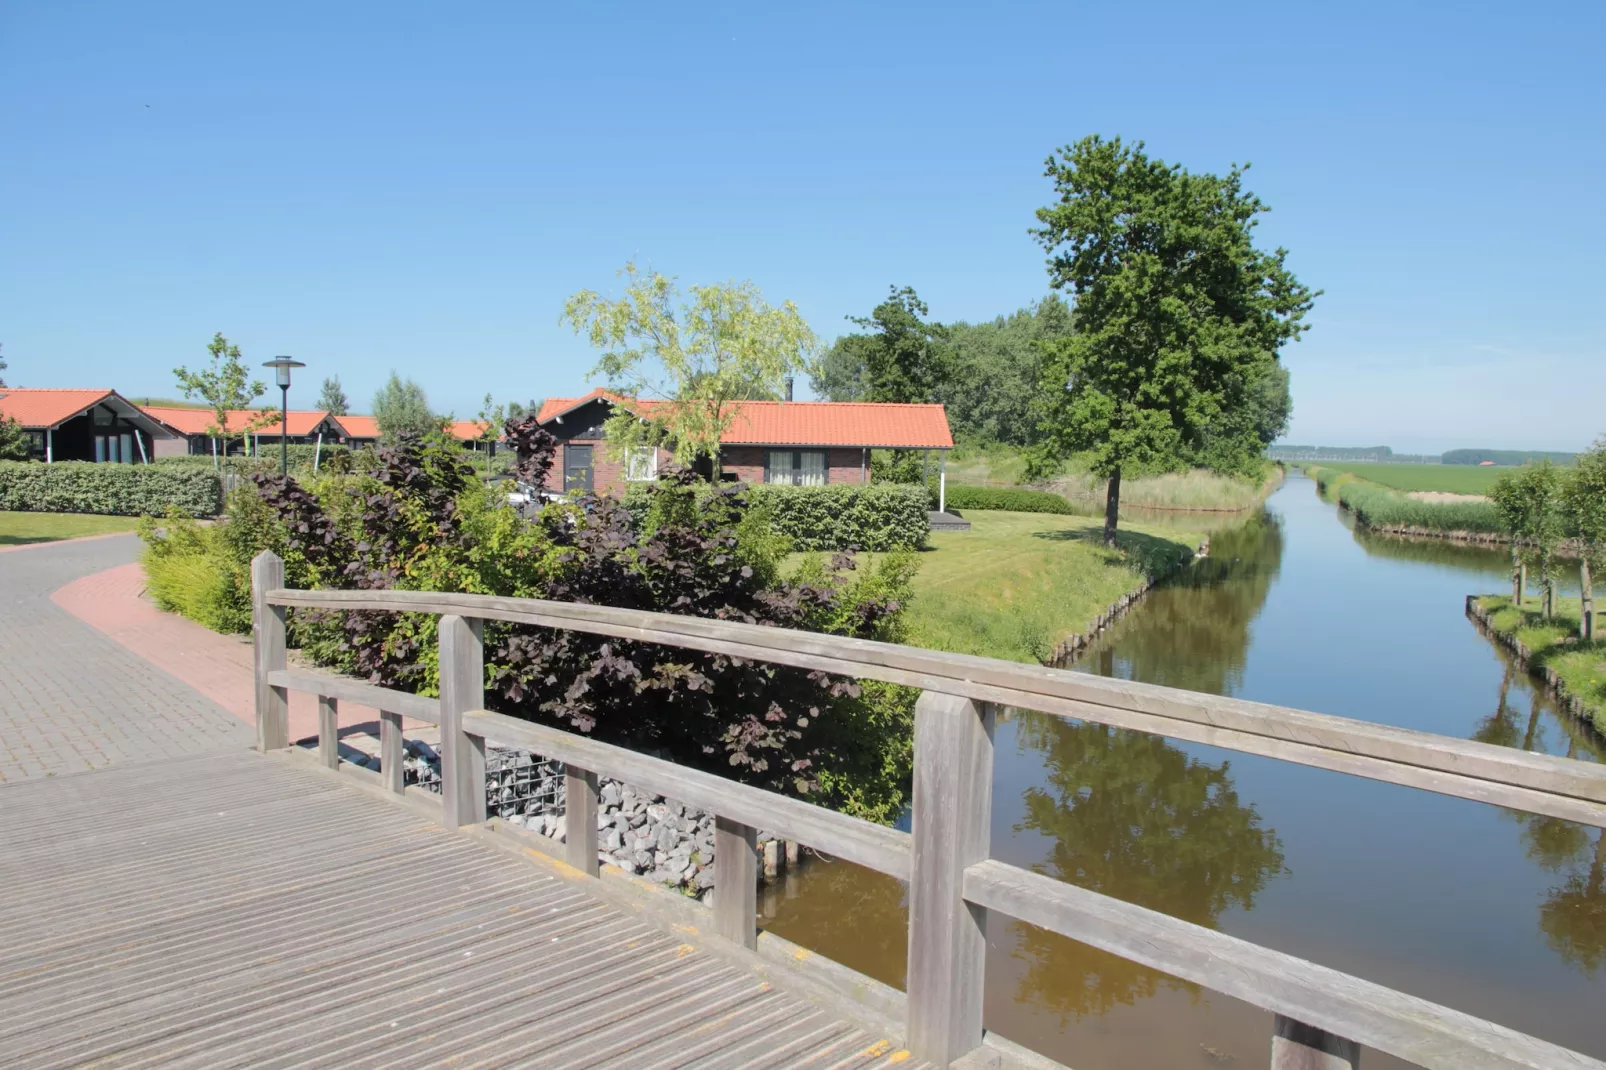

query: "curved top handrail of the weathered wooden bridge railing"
left=267, top=588, right=1606, bottom=816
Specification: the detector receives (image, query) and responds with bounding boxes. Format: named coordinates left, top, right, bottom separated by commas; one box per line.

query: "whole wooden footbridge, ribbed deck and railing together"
left=0, top=554, right=1606, bottom=1070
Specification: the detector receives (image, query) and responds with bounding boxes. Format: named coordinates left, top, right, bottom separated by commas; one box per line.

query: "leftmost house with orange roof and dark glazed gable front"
left=0, top=387, right=175, bottom=464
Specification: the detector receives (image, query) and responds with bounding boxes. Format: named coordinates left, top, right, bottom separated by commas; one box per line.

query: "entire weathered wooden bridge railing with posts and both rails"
left=252, top=554, right=1606, bottom=1070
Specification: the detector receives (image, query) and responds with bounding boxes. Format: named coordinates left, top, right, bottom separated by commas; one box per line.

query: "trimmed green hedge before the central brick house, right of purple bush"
left=748, top=484, right=931, bottom=553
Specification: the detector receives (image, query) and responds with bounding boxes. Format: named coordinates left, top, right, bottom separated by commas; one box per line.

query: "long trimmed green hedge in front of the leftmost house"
left=0, top=461, right=223, bottom=516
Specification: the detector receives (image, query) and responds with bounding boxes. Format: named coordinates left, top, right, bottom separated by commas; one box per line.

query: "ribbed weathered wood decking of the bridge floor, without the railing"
left=0, top=752, right=928, bottom=1070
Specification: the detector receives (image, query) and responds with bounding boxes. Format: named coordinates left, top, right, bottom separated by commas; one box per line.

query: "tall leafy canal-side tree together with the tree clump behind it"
left=813, top=135, right=1319, bottom=546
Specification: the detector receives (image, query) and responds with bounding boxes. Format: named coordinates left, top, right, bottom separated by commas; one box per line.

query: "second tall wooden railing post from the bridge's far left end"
left=440, top=614, right=485, bottom=829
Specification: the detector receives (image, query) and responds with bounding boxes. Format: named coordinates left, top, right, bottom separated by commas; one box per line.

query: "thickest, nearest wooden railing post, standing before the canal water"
left=907, top=691, right=994, bottom=1067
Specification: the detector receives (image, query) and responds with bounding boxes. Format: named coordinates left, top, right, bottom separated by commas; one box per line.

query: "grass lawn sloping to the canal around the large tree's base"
left=873, top=509, right=1203, bottom=662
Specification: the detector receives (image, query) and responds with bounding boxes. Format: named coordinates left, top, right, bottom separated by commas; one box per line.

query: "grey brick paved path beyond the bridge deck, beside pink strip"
left=0, top=535, right=252, bottom=782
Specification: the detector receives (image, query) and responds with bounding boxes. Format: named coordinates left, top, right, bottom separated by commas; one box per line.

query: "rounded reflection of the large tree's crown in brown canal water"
left=1013, top=713, right=1283, bottom=1027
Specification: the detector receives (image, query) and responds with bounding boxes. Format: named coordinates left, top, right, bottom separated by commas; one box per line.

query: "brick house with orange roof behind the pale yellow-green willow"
left=538, top=389, right=954, bottom=507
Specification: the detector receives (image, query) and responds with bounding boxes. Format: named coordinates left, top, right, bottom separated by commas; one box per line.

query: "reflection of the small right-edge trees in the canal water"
left=1473, top=651, right=1606, bottom=977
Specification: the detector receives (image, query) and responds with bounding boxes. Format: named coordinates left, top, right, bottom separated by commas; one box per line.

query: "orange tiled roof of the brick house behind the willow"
left=540, top=389, right=954, bottom=450
